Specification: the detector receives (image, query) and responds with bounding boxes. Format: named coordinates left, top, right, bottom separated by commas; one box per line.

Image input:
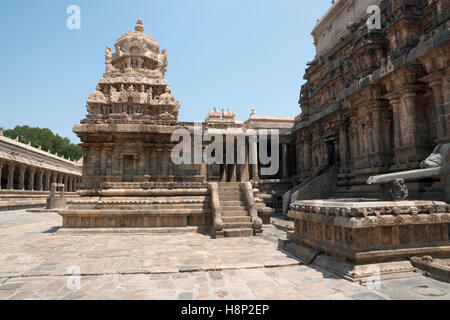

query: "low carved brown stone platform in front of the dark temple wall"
left=288, top=200, right=450, bottom=264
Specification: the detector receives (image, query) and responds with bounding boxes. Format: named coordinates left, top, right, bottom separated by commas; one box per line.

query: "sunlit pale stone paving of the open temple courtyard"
left=0, top=211, right=450, bottom=300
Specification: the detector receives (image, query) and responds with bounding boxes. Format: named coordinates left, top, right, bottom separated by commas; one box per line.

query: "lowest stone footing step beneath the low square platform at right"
left=278, top=239, right=415, bottom=282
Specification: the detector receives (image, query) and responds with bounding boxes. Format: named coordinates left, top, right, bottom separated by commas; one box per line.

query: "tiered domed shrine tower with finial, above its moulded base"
left=73, top=20, right=189, bottom=190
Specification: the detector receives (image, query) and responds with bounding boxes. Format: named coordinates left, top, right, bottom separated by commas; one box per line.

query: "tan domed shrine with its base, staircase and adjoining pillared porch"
left=60, top=20, right=295, bottom=237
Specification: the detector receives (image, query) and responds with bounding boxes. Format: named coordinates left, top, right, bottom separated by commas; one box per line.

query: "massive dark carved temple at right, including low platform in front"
left=280, top=0, right=450, bottom=281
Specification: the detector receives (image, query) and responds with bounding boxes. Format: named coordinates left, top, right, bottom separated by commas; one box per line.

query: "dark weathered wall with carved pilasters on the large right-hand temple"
left=293, top=0, right=450, bottom=197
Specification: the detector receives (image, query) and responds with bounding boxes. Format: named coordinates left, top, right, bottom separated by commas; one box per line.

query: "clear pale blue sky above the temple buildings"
left=0, top=0, right=331, bottom=143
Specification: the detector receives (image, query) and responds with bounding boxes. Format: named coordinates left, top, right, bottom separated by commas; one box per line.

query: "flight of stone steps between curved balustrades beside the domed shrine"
left=219, top=182, right=254, bottom=237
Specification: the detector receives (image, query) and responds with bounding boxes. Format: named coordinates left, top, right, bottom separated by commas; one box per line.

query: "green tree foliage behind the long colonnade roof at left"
left=0, top=126, right=83, bottom=161
